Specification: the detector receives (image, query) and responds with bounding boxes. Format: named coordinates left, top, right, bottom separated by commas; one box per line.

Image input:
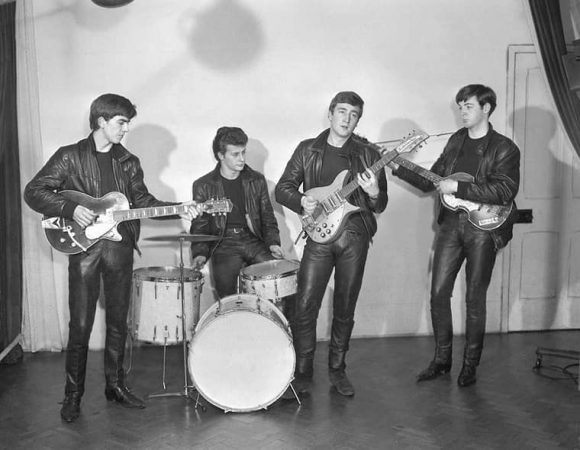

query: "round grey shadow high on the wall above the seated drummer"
left=188, top=0, right=264, bottom=71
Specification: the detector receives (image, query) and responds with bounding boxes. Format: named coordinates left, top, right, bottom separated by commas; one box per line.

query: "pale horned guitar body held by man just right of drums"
left=300, top=170, right=360, bottom=244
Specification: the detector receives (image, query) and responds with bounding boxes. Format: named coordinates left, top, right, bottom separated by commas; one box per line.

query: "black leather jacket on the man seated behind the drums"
left=190, top=163, right=280, bottom=258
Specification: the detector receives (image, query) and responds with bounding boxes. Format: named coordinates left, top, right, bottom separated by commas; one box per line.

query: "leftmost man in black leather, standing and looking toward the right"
left=24, top=94, right=200, bottom=422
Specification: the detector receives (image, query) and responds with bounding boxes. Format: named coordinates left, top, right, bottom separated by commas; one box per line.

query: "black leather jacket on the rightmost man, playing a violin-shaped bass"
left=393, top=124, right=520, bottom=249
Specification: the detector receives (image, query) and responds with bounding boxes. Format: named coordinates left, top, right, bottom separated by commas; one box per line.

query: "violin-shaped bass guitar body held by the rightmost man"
left=440, top=172, right=513, bottom=231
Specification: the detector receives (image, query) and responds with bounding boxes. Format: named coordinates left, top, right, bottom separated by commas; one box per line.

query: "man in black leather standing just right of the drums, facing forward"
left=276, top=91, right=388, bottom=396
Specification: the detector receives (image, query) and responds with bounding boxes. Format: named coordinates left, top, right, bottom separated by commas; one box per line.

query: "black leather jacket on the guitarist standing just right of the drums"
left=276, top=129, right=389, bottom=238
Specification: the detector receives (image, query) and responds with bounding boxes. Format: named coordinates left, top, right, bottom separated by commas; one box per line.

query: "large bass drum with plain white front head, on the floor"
left=188, top=294, right=296, bottom=412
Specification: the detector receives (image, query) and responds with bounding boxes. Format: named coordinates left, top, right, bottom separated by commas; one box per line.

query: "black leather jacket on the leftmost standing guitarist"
left=24, top=133, right=177, bottom=248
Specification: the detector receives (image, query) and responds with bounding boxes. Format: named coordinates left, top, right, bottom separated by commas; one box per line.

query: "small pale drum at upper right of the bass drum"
left=240, top=259, right=300, bottom=306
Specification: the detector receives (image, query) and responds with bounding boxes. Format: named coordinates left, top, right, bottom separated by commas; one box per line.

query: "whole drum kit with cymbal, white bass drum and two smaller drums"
left=129, top=233, right=300, bottom=412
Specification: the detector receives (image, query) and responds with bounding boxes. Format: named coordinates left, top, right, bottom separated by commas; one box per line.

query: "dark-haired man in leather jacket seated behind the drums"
left=190, top=127, right=284, bottom=299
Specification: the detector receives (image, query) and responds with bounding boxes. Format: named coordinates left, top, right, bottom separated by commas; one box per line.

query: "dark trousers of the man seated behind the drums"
left=211, top=230, right=274, bottom=298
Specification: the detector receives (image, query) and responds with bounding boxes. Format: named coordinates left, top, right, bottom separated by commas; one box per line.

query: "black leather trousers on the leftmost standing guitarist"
left=65, top=241, right=133, bottom=396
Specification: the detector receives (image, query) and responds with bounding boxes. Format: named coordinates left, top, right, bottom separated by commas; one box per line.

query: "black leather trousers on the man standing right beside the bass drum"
left=291, top=230, right=369, bottom=377
